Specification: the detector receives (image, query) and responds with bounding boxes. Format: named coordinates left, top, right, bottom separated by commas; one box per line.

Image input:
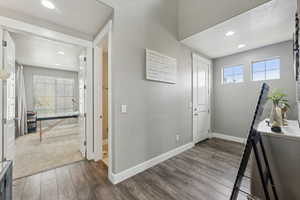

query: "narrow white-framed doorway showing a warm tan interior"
left=94, top=21, right=112, bottom=179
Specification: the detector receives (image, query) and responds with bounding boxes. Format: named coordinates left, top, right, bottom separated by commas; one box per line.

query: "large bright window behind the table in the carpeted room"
left=33, top=75, right=74, bottom=114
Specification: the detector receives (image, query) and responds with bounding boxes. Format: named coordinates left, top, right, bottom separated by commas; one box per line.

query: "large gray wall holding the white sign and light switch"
left=111, top=0, right=192, bottom=173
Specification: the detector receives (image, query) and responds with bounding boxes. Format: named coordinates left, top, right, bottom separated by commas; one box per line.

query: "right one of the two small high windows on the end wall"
left=252, top=58, right=280, bottom=81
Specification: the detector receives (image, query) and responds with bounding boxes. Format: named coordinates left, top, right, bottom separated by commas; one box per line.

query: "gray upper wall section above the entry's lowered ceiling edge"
left=178, top=0, right=270, bottom=40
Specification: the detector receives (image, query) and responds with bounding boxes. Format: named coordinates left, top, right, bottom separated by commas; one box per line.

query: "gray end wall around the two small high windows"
left=212, top=41, right=297, bottom=138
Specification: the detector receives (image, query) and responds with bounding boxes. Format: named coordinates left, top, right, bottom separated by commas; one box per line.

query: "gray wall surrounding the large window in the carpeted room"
left=23, top=65, right=79, bottom=110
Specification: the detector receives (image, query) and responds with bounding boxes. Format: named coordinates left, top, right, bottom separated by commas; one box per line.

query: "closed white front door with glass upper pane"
left=193, top=54, right=210, bottom=143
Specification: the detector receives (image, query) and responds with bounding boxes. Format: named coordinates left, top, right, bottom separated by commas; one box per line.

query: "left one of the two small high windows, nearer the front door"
left=223, top=65, right=244, bottom=84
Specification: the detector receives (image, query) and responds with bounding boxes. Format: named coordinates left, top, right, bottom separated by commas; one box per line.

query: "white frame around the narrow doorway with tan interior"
left=93, top=20, right=113, bottom=182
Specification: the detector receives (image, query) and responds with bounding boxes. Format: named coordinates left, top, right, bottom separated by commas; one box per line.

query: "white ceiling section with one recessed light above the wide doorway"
left=0, top=0, right=113, bottom=40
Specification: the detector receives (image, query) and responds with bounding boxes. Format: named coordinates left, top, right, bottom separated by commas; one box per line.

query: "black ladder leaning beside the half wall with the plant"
left=230, top=83, right=278, bottom=200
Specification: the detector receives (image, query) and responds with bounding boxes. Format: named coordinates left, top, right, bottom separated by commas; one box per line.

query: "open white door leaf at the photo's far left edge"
left=3, top=31, right=16, bottom=160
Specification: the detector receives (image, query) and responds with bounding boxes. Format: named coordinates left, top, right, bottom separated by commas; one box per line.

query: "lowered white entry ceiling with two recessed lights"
left=182, top=0, right=297, bottom=58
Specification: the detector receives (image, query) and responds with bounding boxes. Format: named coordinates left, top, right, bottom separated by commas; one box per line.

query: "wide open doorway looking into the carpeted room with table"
left=4, top=30, right=86, bottom=179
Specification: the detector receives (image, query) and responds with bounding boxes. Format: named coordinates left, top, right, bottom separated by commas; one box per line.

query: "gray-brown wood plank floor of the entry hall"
left=13, top=139, right=249, bottom=200
